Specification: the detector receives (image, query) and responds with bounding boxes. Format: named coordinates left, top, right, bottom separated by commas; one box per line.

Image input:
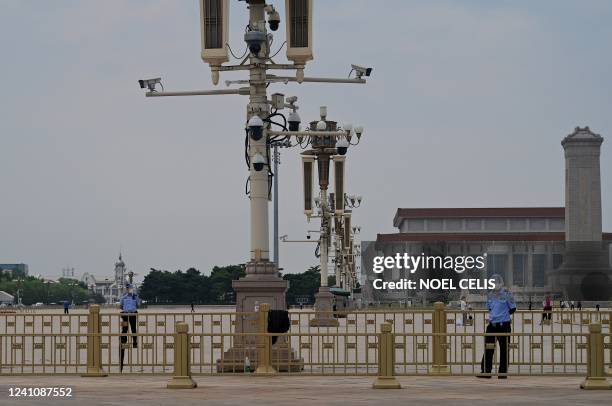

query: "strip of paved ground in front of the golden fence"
left=0, top=376, right=612, bottom=406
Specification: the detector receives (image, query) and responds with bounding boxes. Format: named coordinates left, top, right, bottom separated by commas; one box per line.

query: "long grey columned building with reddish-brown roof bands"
left=361, top=207, right=612, bottom=302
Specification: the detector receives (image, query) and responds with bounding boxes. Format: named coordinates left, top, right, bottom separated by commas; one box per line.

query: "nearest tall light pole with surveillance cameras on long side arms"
left=139, top=0, right=372, bottom=368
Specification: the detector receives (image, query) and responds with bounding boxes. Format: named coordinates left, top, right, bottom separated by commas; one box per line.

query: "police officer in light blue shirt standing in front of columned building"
left=478, top=274, right=516, bottom=379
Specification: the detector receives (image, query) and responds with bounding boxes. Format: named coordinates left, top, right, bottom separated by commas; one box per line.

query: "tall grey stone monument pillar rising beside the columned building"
left=549, top=127, right=611, bottom=301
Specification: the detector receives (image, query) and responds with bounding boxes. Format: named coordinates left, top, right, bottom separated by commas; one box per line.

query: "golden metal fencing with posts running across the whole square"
left=0, top=303, right=612, bottom=382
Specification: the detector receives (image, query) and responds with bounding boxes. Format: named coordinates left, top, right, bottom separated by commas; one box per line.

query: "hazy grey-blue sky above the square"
left=0, top=0, right=612, bottom=279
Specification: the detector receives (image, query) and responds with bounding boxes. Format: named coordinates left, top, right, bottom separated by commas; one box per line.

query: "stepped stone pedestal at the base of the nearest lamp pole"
left=217, top=261, right=304, bottom=372
